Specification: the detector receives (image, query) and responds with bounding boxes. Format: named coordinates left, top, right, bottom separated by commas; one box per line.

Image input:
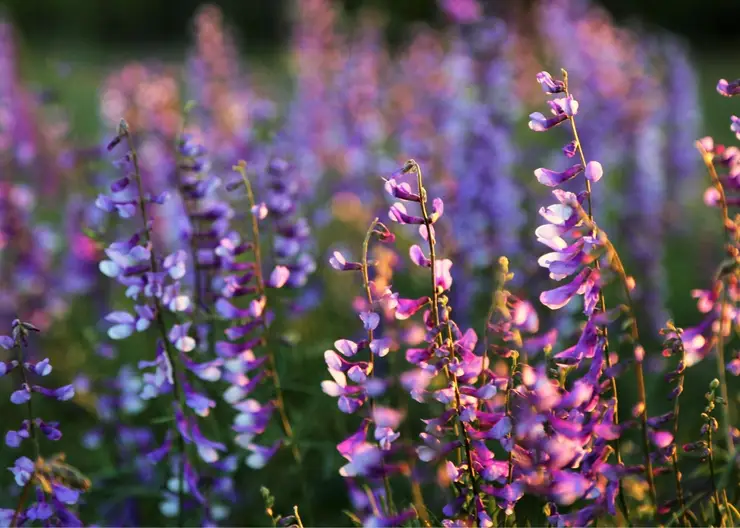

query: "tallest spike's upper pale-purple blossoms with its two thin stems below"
left=530, top=70, right=657, bottom=518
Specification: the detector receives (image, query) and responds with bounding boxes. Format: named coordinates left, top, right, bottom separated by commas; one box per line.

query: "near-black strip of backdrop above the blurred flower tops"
left=0, top=0, right=740, bottom=52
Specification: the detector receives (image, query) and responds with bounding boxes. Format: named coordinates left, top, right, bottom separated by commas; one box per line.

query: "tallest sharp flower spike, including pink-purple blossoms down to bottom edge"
left=528, top=71, right=673, bottom=525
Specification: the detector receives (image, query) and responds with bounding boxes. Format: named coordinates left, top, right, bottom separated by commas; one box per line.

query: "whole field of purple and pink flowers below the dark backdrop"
left=0, top=0, right=740, bottom=528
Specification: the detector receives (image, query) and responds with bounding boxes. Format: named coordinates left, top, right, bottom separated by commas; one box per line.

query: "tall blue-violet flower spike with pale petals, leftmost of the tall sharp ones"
left=96, top=125, right=226, bottom=516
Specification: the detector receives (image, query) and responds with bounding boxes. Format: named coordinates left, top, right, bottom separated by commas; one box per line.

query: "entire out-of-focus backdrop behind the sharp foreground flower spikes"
left=0, top=0, right=740, bottom=525
